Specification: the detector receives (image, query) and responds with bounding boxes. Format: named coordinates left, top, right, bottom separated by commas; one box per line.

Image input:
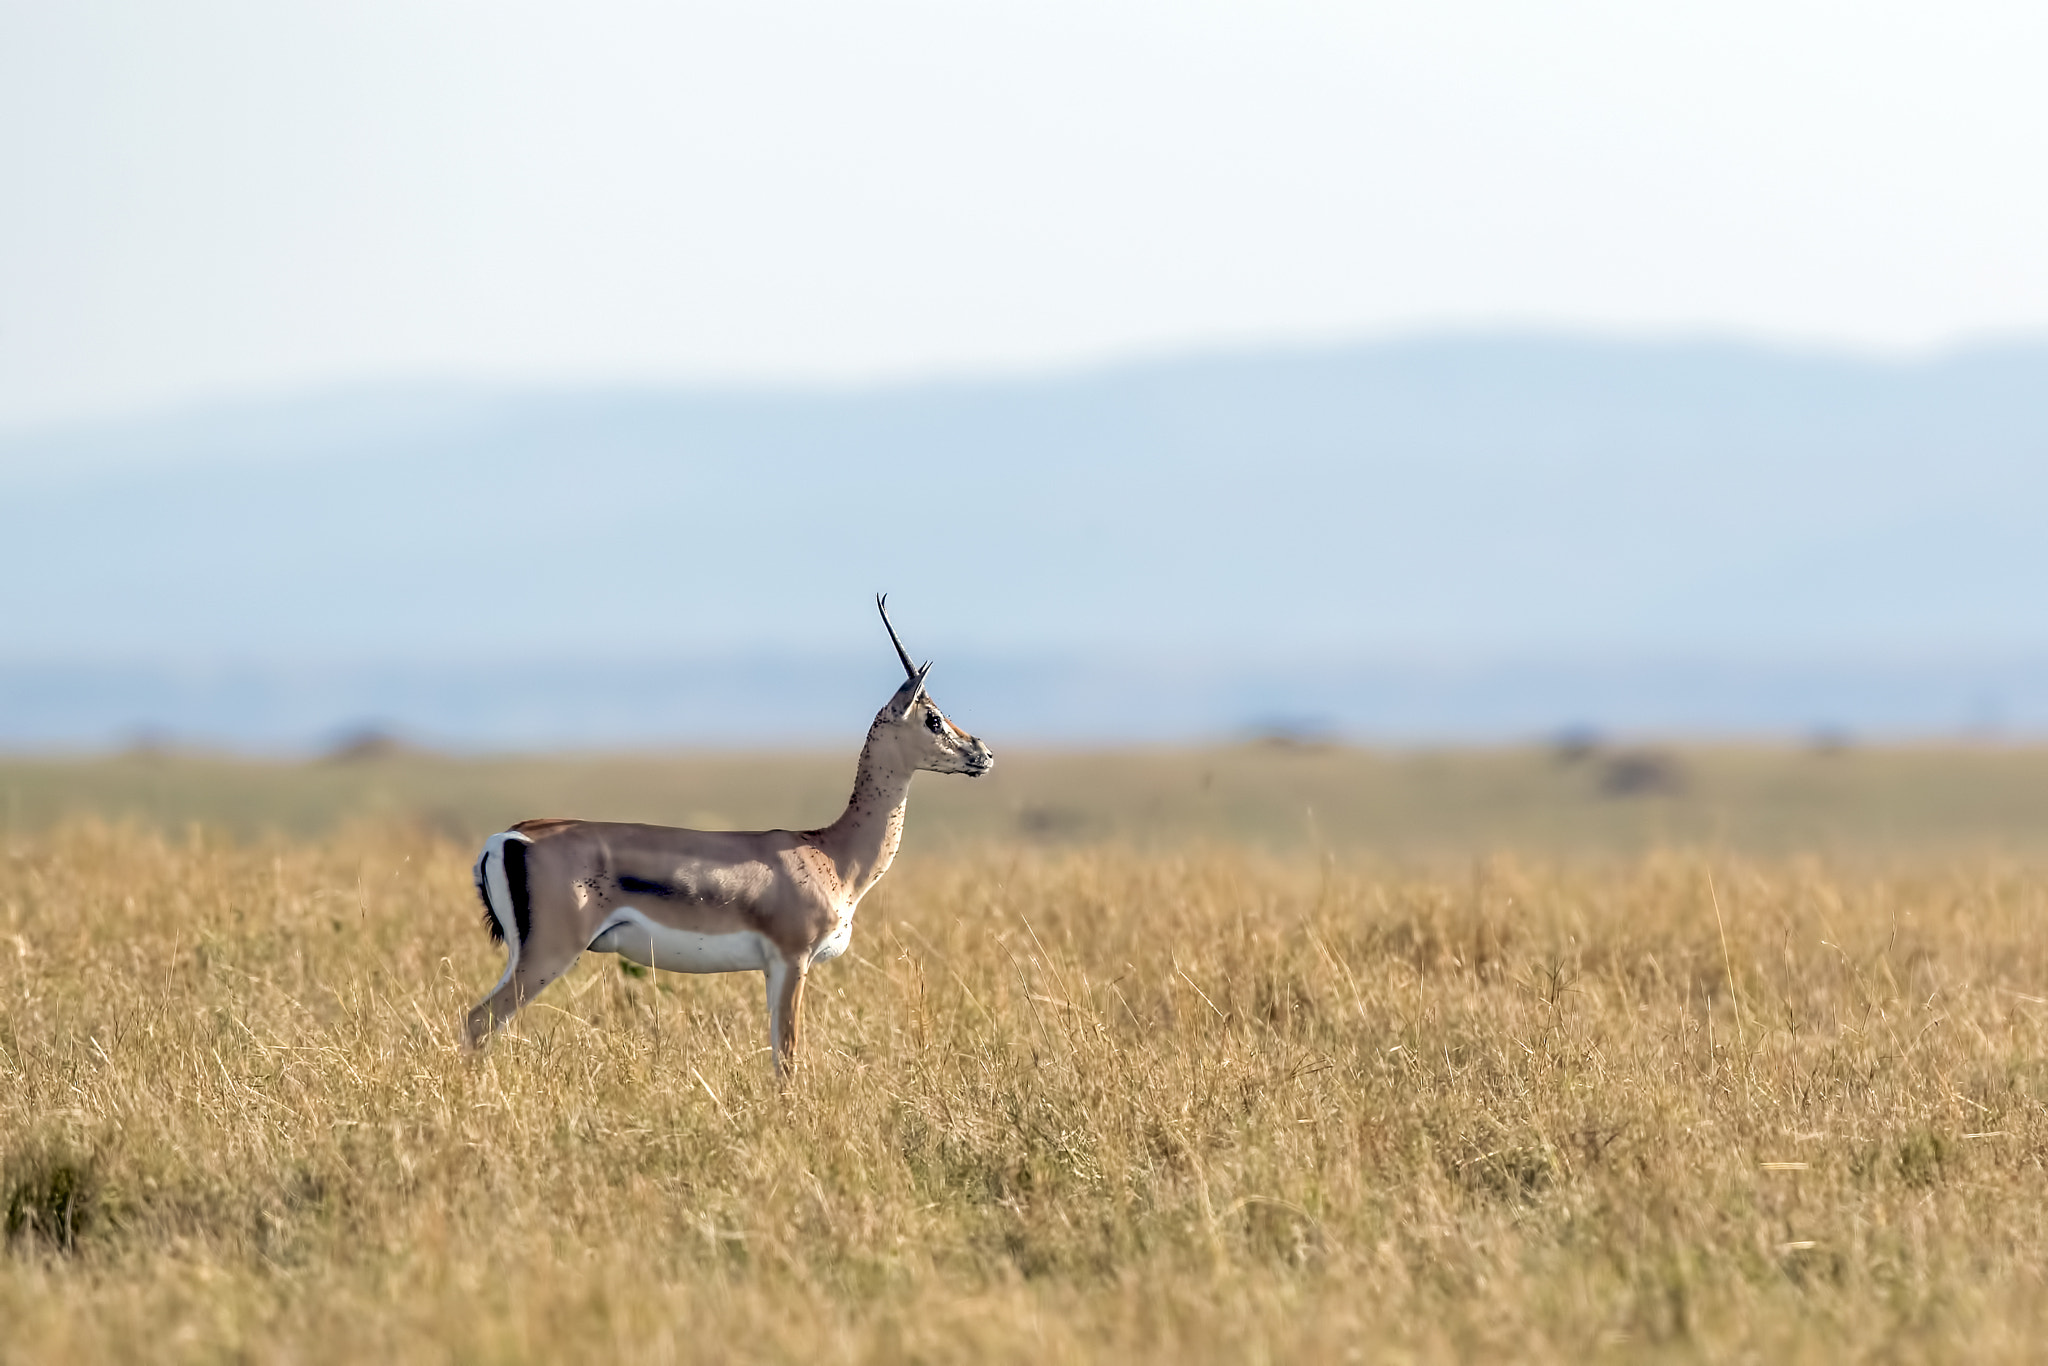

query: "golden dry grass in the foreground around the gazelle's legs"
left=0, top=823, right=2048, bottom=1362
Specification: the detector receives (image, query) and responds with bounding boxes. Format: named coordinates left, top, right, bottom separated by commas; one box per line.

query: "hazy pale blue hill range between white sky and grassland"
left=0, top=336, right=2048, bottom=743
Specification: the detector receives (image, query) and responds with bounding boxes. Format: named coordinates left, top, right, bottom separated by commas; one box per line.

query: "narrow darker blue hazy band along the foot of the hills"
left=0, top=655, right=2048, bottom=760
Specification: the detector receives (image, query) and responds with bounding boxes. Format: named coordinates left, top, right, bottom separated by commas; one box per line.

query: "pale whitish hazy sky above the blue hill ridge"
left=0, top=0, right=2048, bottom=426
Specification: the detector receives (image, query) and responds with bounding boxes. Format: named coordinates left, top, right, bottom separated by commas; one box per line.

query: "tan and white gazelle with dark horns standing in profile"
left=467, top=596, right=995, bottom=1077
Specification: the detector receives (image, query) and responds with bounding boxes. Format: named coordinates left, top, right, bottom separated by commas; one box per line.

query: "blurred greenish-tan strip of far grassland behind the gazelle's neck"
left=12, top=743, right=2048, bottom=860
